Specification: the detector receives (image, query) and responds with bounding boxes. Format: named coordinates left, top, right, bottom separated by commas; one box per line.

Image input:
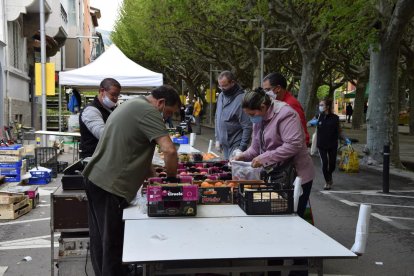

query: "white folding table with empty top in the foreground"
left=122, top=205, right=357, bottom=275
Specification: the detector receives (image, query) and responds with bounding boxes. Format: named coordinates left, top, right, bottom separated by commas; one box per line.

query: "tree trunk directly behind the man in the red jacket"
left=298, top=51, right=322, bottom=120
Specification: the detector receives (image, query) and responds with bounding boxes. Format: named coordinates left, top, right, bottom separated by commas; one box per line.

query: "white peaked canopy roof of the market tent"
left=59, top=44, right=163, bottom=88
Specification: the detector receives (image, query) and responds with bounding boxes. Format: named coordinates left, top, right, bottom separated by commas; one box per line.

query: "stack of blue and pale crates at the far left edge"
left=0, top=144, right=26, bottom=182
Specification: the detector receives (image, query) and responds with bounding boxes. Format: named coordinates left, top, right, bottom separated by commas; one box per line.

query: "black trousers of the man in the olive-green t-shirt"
left=85, top=179, right=128, bottom=276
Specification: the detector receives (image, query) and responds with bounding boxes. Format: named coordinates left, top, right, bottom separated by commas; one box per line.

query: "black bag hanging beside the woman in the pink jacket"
left=260, top=158, right=297, bottom=189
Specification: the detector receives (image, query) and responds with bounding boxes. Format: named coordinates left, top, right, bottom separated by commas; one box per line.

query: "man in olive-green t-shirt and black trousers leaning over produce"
left=82, top=85, right=181, bottom=276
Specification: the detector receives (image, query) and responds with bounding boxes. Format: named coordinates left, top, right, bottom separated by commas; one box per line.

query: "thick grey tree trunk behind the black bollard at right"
left=366, top=44, right=400, bottom=165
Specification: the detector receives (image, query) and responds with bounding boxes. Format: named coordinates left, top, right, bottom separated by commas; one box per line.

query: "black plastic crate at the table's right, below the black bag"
left=238, top=183, right=293, bottom=215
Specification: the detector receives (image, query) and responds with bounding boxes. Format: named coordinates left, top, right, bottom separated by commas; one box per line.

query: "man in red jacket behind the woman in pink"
left=262, top=73, right=310, bottom=145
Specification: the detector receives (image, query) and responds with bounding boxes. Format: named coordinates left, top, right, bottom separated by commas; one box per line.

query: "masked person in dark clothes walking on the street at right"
left=316, top=99, right=351, bottom=190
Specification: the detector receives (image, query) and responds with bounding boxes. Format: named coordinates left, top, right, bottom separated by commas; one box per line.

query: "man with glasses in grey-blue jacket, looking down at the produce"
left=215, top=71, right=252, bottom=159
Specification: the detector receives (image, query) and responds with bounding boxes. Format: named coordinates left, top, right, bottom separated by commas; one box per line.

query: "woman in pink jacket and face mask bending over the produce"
left=235, top=89, right=315, bottom=218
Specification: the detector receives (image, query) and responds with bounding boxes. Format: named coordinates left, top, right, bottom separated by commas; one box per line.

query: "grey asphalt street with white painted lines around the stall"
left=0, top=124, right=414, bottom=276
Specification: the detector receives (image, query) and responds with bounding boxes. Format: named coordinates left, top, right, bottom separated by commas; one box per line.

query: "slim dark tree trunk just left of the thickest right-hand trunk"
left=352, top=73, right=368, bottom=129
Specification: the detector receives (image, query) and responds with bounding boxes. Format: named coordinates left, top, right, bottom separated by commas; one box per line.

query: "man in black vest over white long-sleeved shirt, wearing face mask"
left=79, top=78, right=121, bottom=158
